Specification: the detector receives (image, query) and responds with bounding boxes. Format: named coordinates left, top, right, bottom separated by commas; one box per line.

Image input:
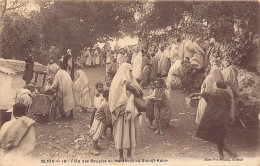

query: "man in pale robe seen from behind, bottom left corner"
left=0, top=103, right=35, bottom=161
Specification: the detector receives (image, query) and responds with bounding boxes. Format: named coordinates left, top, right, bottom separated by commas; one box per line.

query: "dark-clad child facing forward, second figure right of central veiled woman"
left=154, top=78, right=171, bottom=135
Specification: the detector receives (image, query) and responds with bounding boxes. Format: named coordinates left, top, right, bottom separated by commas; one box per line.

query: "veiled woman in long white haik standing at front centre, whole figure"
left=108, top=63, right=141, bottom=160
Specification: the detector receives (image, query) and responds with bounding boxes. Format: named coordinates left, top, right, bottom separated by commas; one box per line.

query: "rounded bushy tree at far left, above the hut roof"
left=1, top=13, right=40, bottom=59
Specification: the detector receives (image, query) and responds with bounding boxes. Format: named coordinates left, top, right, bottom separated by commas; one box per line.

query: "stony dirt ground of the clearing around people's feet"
left=33, top=67, right=260, bottom=160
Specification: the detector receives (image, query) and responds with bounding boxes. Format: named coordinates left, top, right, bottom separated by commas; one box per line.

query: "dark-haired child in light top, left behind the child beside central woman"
left=90, top=82, right=104, bottom=127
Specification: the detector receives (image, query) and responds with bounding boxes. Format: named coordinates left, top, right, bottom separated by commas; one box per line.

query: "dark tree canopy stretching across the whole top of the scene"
left=1, top=0, right=259, bottom=69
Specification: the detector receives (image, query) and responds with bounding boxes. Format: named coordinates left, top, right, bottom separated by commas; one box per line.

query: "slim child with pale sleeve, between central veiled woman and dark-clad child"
left=144, top=82, right=156, bottom=129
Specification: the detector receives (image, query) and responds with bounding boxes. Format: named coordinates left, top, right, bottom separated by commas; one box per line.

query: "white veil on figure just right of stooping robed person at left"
left=75, top=70, right=90, bottom=92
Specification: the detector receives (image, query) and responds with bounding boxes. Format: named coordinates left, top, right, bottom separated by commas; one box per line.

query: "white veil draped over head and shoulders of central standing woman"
left=108, top=63, right=141, bottom=112
